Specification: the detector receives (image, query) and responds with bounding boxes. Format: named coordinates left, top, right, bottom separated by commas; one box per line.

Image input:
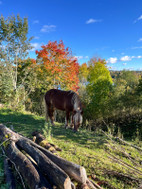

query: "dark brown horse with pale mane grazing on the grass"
left=45, top=89, right=83, bottom=132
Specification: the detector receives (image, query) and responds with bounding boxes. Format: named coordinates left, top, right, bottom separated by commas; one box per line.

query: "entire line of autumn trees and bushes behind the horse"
left=0, top=15, right=142, bottom=137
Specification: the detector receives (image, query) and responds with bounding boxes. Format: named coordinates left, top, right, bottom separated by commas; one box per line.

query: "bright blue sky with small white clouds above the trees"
left=0, top=0, right=142, bottom=70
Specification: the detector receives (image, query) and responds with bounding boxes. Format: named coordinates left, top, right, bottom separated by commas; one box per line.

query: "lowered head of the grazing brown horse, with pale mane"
left=73, top=108, right=83, bottom=131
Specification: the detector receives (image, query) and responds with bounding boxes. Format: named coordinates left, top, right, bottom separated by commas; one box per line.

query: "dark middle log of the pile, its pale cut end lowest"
left=16, top=138, right=71, bottom=189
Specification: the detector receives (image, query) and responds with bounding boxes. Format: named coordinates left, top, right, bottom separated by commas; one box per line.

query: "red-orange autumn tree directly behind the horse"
left=36, top=40, right=79, bottom=91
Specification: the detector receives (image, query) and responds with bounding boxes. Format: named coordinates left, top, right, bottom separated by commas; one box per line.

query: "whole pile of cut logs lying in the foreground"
left=0, top=124, right=97, bottom=189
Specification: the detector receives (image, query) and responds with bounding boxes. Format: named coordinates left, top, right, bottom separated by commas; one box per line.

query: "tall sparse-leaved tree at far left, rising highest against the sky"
left=0, top=15, right=32, bottom=108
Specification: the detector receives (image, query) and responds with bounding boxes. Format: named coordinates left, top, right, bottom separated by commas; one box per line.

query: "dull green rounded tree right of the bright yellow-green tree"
left=113, top=70, right=139, bottom=109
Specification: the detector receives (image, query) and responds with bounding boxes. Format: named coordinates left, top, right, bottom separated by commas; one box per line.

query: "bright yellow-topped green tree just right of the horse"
left=87, top=58, right=113, bottom=118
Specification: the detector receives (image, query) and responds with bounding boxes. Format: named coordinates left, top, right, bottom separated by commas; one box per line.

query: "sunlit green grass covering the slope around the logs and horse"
left=0, top=109, right=142, bottom=189
